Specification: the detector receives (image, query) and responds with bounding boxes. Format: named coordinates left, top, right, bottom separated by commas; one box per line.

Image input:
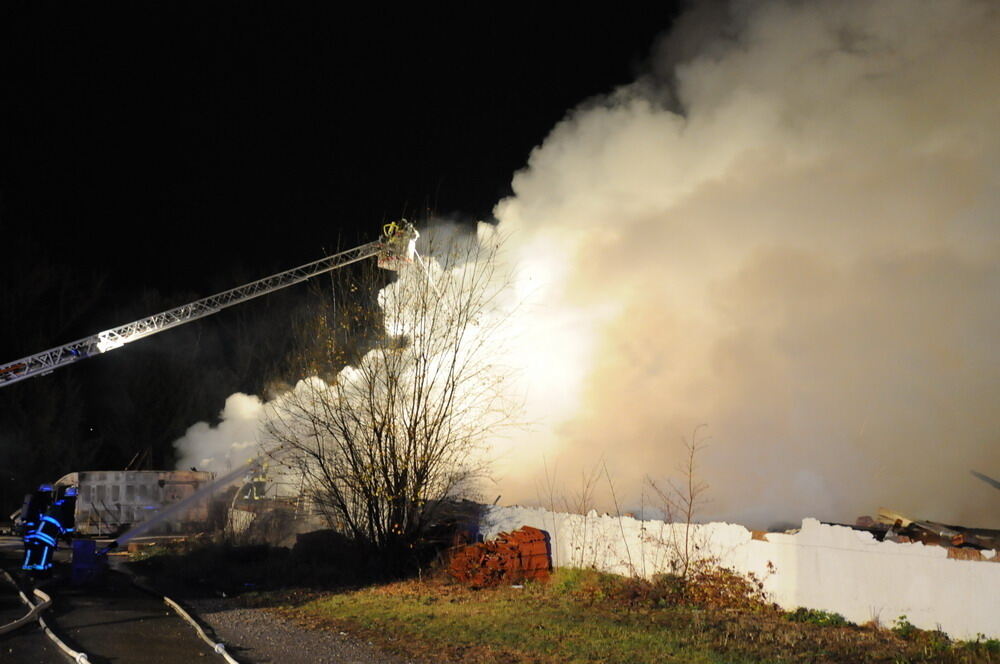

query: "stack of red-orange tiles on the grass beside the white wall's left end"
left=448, top=526, right=552, bottom=588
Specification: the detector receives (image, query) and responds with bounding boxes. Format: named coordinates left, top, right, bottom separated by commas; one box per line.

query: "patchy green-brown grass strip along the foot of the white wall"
left=279, top=570, right=1000, bottom=664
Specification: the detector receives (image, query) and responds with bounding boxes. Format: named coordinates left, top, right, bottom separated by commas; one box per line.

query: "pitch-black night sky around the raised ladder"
left=0, top=2, right=676, bottom=473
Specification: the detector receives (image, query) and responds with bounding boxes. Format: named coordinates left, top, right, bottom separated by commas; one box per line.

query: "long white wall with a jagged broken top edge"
left=481, top=507, right=1000, bottom=639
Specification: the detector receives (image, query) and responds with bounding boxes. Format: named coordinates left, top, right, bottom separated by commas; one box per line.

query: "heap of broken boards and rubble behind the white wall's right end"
left=852, top=507, right=1000, bottom=560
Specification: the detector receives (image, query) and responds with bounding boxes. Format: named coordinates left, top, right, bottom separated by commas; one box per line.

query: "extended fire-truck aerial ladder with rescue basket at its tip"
left=0, top=219, right=422, bottom=387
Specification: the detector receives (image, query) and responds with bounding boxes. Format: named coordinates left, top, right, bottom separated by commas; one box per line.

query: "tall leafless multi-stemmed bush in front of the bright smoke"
left=267, top=227, right=515, bottom=550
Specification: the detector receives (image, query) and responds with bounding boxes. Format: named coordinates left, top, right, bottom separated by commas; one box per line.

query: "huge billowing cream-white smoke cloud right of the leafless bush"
left=178, top=0, right=1000, bottom=527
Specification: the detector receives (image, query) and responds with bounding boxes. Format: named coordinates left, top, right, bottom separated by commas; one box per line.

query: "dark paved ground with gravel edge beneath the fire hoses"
left=0, top=537, right=422, bottom=664
